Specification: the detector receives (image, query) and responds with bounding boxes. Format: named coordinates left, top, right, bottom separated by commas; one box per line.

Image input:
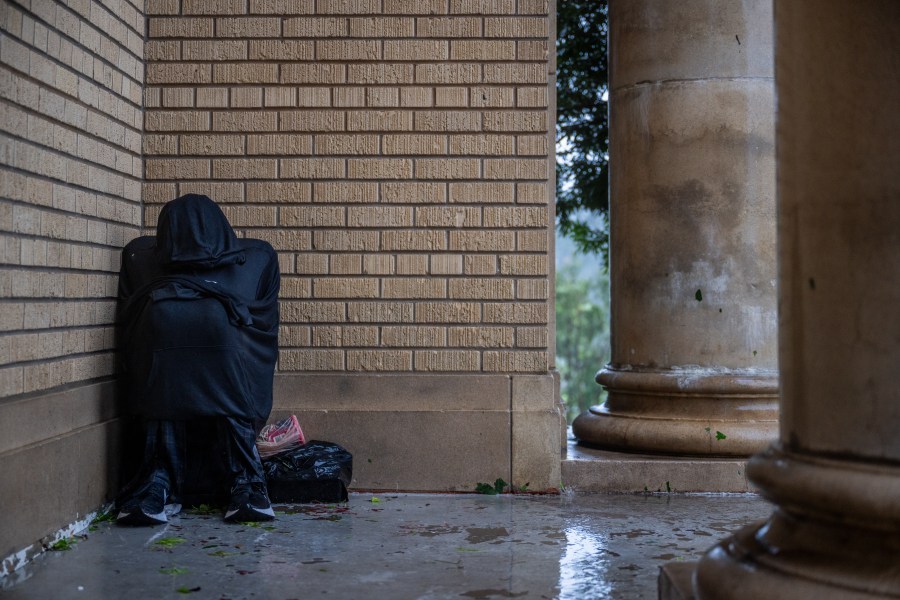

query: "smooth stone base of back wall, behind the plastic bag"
left=272, top=373, right=561, bottom=492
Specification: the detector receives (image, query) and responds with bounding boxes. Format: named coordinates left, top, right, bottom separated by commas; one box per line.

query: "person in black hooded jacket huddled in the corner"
left=117, top=194, right=280, bottom=524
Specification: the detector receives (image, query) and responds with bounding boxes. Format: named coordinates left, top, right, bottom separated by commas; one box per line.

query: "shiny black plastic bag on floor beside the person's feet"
left=263, top=440, right=353, bottom=502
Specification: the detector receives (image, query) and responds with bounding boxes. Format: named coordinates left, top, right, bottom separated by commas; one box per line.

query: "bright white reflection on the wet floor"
left=559, top=525, right=612, bottom=600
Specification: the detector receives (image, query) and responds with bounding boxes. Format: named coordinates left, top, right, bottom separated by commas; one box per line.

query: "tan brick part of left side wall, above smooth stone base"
left=0, top=0, right=142, bottom=397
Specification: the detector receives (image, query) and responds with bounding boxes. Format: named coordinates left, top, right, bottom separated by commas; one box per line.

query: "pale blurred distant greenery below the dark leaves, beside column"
left=556, top=240, right=609, bottom=423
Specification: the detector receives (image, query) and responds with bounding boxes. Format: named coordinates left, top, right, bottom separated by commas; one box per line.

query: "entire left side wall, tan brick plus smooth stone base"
left=0, top=0, right=144, bottom=571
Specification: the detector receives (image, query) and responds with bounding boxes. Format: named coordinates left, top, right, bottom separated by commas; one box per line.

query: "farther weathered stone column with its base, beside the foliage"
left=574, top=0, right=777, bottom=456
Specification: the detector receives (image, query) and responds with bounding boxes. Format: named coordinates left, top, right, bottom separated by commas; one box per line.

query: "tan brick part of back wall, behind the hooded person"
left=143, top=0, right=554, bottom=373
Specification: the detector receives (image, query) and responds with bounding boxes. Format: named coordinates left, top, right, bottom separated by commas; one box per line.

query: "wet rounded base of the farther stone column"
left=572, top=368, right=778, bottom=456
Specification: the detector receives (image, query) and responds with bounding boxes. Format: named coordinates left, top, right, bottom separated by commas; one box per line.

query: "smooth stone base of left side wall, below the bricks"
left=0, top=380, right=121, bottom=559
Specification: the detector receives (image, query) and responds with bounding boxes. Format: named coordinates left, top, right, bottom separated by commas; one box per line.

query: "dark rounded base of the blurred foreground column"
left=694, top=448, right=900, bottom=600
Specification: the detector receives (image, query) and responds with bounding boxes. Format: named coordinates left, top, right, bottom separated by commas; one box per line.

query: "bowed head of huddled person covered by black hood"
left=156, top=194, right=244, bottom=269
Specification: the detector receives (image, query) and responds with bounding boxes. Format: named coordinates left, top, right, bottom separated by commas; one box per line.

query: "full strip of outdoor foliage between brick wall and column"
left=556, top=0, right=609, bottom=423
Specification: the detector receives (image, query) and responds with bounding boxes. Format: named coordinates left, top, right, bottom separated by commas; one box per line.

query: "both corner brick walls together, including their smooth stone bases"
left=0, top=0, right=561, bottom=552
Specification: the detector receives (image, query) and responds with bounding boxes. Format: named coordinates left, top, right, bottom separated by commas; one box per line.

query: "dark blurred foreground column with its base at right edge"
left=695, top=0, right=900, bottom=600
